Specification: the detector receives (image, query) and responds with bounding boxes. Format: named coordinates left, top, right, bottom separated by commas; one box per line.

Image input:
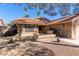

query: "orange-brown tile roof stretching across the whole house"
left=12, top=14, right=79, bottom=25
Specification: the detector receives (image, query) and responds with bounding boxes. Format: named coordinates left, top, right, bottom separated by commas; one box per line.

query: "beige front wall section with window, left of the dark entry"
left=17, top=24, right=38, bottom=36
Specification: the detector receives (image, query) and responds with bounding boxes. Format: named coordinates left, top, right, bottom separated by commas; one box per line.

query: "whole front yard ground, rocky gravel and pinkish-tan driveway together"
left=0, top=37, right=79, bottom=56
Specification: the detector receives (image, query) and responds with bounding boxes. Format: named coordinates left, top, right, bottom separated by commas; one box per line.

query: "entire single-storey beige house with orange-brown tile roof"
left=12, top=14, right=79, bottom=38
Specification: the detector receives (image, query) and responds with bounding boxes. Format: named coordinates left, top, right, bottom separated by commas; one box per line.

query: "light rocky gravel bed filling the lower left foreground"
left=0, top=37, right=55, bottom=56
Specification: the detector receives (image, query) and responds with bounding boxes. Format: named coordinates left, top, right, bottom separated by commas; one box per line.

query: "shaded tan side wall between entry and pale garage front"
left=51, top=23, right=72, bottom=38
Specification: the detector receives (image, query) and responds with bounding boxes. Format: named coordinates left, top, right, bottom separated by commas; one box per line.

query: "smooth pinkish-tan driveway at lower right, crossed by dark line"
left=31, top=38, right=79, bottom=56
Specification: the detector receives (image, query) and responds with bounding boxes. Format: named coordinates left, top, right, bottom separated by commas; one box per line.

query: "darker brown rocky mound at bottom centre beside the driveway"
left=26, top=45, right=55, bottom=56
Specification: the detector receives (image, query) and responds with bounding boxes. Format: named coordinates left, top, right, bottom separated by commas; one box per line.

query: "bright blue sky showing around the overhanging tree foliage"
left=0, top=3, right=61, bottom=23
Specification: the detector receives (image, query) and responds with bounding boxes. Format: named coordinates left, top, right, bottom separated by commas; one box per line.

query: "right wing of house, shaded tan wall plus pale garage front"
left=51, top=16, right=79, bottom=39
